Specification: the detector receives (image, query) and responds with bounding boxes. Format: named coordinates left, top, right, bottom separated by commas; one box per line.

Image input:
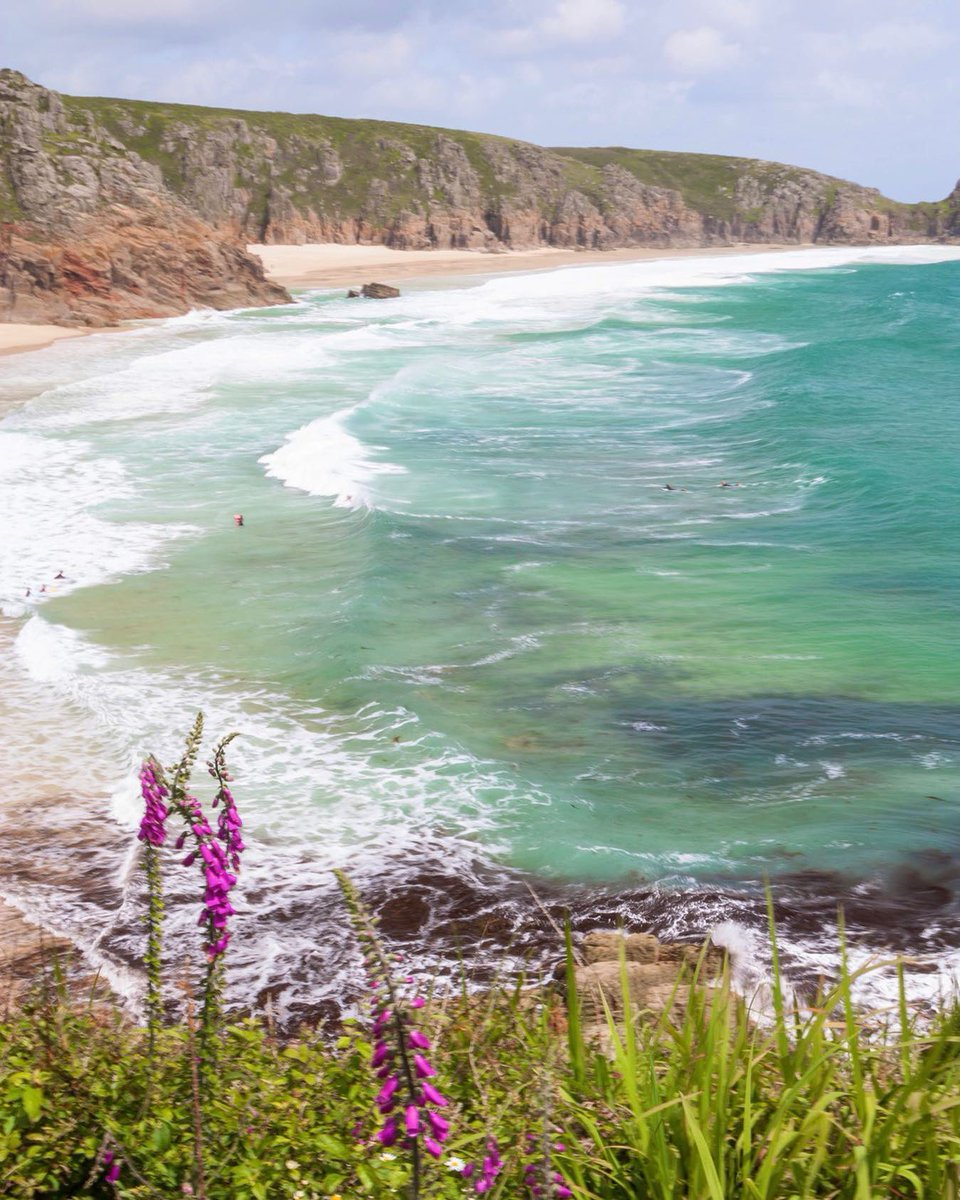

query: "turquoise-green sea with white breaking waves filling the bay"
left=0, top=247, right=960, bottom=1012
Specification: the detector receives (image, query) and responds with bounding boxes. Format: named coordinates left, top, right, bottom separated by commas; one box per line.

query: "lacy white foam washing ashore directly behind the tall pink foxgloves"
left=0, top=616, right=559, bottom=1002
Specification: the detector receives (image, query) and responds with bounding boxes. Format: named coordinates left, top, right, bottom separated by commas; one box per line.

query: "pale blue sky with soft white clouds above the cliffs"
left=7, top=0, right=960, bottom=200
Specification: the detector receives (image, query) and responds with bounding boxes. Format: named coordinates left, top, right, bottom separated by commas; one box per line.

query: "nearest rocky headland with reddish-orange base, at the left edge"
left=0, top=72, right=289, bottom=325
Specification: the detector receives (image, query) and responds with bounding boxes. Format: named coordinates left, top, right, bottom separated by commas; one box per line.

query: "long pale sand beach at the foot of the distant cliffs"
left=247, top=242, right=806, bottom=288
